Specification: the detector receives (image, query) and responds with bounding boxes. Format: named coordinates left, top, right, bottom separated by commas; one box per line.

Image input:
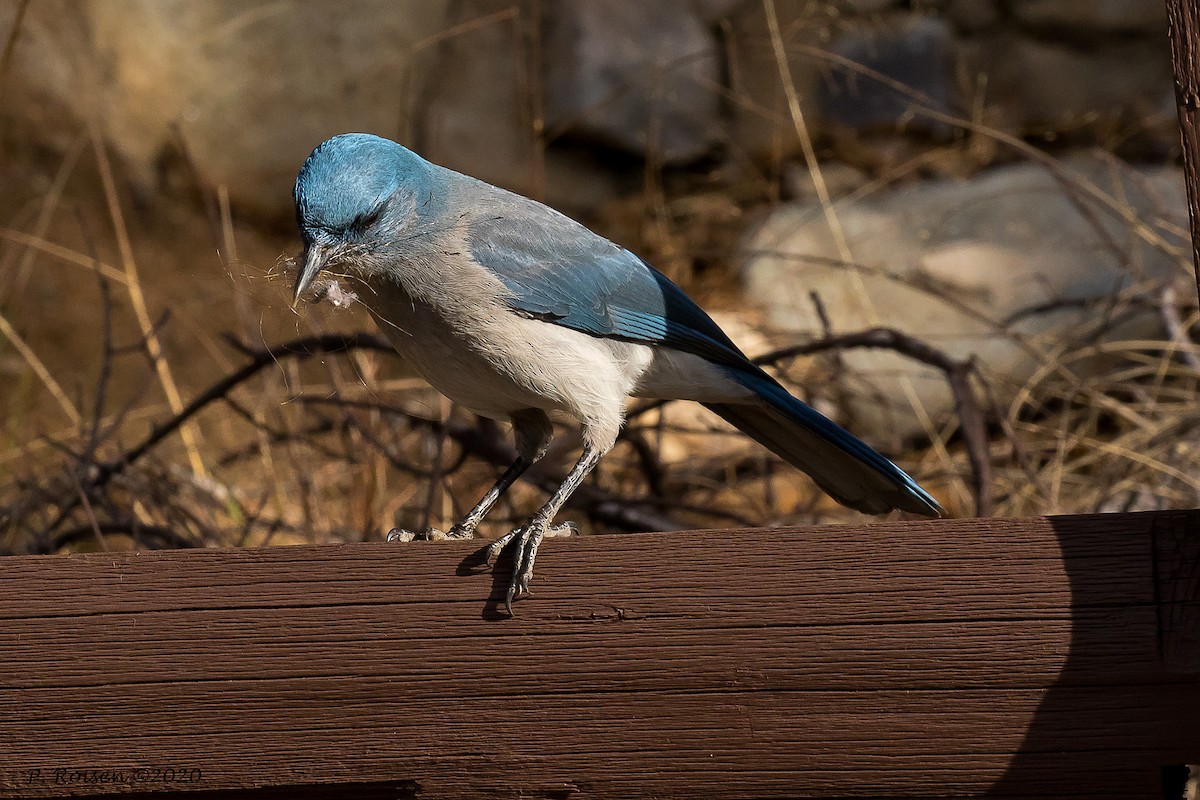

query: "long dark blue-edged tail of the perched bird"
left=704, top=373, right=942, bottom=517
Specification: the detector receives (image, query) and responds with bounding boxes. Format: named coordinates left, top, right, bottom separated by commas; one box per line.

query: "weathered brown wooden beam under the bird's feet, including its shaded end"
left=0, top=512, right=1200, bottom=799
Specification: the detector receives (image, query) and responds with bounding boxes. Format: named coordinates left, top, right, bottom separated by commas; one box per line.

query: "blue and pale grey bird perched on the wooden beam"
left=293, top=133, right=942, bottom=615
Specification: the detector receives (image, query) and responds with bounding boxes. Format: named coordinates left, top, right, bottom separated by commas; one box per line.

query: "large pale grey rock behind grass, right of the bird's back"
left=742, top=157, right=1187, bottom=444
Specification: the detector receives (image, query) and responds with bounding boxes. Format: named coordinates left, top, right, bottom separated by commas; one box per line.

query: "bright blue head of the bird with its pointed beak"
left=293, top=133, right=428, bottom=303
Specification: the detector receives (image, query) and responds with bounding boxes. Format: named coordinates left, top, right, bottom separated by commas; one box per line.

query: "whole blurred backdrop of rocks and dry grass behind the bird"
left=0, top=0, right=1200, bottom=552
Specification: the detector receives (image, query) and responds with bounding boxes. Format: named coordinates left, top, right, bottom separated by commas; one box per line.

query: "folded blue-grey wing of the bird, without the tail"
left=469, top=206, right=750, bottom=368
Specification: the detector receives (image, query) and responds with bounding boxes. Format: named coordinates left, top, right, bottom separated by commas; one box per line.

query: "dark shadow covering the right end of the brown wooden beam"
left=989, top=512, right=1200, bottom=800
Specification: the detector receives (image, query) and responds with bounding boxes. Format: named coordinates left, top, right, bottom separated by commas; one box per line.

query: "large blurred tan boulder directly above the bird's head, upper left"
left=80, top=0, right=448, bottom=216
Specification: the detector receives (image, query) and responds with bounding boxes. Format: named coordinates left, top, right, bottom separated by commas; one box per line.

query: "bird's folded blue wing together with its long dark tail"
left=469, top=196, right=941, bottom=517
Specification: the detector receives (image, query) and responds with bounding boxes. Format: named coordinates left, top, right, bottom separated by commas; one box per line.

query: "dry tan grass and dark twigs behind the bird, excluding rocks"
left=0, top=2, right=1200, bottom=553
